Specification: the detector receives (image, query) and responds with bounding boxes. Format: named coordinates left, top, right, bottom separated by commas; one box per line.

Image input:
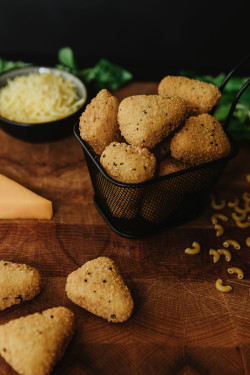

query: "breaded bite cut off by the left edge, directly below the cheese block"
left=0, top=260, right=41, bottom=310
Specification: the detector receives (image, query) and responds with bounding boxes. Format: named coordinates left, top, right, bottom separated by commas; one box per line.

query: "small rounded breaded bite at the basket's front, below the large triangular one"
left=100, top=142, right=156, bottom=184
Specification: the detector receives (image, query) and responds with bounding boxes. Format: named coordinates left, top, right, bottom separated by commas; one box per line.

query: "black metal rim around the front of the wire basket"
left=74, top=121, right=239, bottom=189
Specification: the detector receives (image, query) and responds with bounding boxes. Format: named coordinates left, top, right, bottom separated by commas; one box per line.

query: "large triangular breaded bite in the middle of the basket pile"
left=118, top=95, right=187, bottom=148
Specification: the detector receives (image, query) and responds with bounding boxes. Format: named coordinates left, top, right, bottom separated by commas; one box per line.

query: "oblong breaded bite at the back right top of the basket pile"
left=158, top=76, right=221, bottom=115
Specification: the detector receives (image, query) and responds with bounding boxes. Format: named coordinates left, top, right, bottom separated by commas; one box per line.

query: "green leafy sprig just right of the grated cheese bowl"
left=57, top=47, right=133, bottom=91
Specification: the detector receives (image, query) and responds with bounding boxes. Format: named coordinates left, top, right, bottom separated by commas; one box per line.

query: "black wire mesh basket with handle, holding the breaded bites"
left=74, top=55, right=250, bottom=238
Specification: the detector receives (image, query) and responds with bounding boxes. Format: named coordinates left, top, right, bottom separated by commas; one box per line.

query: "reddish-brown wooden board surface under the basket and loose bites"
left=0, top=83, right=250, bottom=375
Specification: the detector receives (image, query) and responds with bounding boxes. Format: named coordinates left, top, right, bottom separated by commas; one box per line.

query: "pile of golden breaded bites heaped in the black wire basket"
left=80, top=76, right=230, bottom=218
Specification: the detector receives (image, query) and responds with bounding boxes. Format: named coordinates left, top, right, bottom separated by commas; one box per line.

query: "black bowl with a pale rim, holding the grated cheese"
left=0, top=66, right=87, bottom=142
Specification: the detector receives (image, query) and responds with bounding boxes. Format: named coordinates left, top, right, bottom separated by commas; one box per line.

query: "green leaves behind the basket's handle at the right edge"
left=180, top=70, right=250, bottom=139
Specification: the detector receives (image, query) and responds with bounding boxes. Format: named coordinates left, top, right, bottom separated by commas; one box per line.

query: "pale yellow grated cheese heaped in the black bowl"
left=0, top=72, right=85, bottom=124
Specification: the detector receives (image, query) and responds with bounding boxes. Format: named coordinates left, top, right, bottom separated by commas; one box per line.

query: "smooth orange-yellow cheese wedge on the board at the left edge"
left=0, top=174, right=53, bottom=219
